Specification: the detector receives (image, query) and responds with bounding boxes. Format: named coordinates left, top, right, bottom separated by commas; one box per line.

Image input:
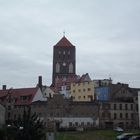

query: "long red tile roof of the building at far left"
left=0, top=87, right=38, bottom=105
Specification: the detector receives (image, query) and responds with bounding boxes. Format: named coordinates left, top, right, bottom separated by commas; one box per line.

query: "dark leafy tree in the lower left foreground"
left=8, top=109, right=46, bottom=140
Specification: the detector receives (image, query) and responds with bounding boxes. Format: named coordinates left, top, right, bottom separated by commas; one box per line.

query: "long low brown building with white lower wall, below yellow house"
left=31, top=94, right=99, bottom=128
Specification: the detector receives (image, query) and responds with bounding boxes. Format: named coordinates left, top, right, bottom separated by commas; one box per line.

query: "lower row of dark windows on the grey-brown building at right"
left=102, top=113, right=134, bottom=119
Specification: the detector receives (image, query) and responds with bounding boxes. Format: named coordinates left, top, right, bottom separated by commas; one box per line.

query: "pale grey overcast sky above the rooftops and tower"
left=0, top=0, right=140, bottom=88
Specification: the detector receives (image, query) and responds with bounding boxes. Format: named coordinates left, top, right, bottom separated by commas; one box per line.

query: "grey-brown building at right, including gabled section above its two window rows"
left=99, top=83, right=139, bottom=129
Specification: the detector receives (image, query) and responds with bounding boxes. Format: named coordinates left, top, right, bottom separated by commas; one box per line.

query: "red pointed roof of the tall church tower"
left=55, top=36, right=73, bottom=47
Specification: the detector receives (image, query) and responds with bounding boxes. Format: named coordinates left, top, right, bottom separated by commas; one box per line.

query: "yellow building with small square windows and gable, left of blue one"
left=70, top=74, right=94, bottom=101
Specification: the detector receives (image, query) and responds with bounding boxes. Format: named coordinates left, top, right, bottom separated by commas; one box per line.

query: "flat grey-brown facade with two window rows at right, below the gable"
left=99, top=102, right=138, bottom=129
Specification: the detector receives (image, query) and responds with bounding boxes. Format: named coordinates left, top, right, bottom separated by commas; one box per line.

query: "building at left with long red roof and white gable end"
left=0, top=87, right=45, bottom=122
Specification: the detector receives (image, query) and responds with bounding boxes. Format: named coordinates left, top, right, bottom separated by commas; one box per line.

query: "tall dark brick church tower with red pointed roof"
left=52, top=36, right=76, bottom=84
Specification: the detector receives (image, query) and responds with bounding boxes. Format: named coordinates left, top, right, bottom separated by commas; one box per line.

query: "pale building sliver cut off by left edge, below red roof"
left=0, top=104, right=5, bottom=128
